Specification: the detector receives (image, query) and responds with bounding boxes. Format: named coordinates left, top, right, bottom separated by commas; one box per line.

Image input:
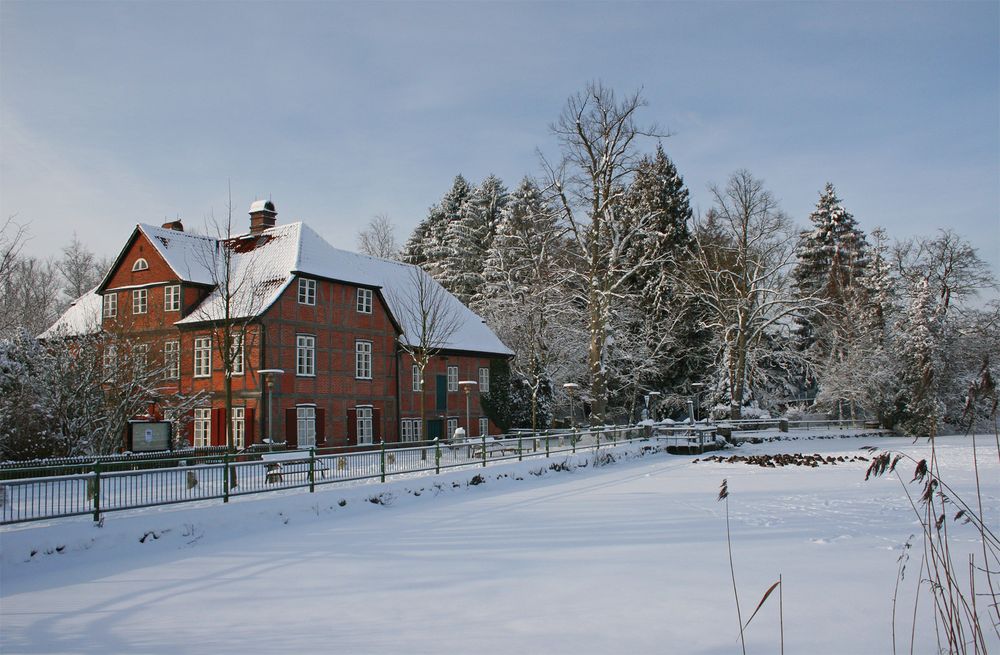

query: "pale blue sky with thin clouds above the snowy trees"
left=0, top=0, right=1000, bottom=280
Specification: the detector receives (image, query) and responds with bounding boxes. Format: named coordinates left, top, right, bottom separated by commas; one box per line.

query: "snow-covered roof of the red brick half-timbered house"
left=50, top=218, right=513, bottom=355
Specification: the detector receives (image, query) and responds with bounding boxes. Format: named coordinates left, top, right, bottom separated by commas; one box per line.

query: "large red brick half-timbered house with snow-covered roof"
left=47, top=201, right=512, bottom=447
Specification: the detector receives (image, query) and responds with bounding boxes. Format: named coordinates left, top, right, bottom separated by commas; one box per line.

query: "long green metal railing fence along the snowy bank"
left=0, top=426, right=650, bottom=524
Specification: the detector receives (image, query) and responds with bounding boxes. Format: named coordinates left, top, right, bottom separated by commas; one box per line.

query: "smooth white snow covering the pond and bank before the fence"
left=0, top=437, right=1000, bottom=654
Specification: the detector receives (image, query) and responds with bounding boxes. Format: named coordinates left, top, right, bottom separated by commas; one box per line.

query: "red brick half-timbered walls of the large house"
left=95, top=227, right=498, bottom=447
